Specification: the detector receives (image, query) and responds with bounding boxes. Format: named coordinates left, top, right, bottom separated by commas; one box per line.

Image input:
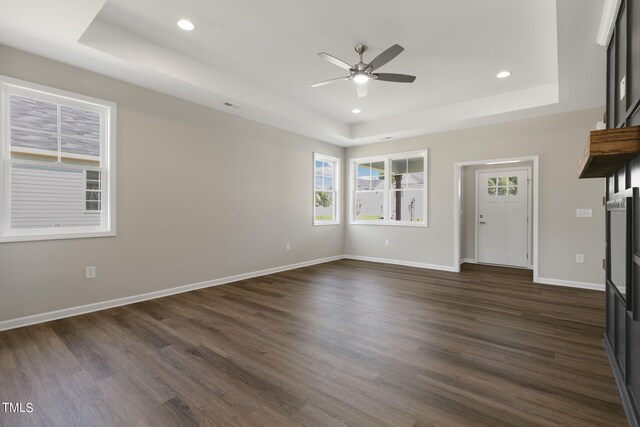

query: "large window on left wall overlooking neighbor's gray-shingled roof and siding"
left=0, top=77, right=115, bottom=242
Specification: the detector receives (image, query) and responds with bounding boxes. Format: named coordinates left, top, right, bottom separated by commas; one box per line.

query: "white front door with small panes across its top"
left=476, top=169, right=529, bottom=267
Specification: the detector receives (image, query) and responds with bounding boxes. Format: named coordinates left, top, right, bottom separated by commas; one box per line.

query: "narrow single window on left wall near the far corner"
left=313, top=153, right=340, bottom=225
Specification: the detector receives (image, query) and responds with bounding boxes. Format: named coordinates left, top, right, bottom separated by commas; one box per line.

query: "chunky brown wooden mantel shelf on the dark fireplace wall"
left=578, top=126, right=640, bottom=178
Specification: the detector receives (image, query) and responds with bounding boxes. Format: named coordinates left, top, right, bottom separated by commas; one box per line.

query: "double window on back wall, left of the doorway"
left=351, top=151, right=427, bottom=226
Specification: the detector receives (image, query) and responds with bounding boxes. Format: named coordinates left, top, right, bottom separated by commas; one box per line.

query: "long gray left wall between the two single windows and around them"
left=0, top=45, right=344, bottom=321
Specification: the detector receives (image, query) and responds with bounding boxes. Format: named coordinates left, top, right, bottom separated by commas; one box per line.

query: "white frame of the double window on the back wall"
left=349, top=149, right=429, bottom=228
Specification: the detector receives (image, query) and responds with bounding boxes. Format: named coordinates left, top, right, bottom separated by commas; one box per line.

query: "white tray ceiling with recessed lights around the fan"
left=0, top=0, right=605, bottom=146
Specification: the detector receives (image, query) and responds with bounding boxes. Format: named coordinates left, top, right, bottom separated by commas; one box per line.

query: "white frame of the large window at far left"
left=0, top=75, right=117, bottom=243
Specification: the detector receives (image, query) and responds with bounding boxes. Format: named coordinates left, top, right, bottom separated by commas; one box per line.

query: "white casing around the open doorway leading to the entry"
left=453, top=156, right=540, bottom=282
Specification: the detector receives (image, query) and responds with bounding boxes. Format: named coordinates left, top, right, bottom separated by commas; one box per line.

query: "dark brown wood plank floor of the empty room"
left=0, top=260, right=626, bottom=427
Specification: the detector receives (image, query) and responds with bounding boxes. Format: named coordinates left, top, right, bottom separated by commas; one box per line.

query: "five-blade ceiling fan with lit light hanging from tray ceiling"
left=311, top=44, right=416, bottom=98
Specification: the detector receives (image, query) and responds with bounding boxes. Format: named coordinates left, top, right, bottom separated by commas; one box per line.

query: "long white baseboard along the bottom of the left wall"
left=0, top=255, right=344, bottom=331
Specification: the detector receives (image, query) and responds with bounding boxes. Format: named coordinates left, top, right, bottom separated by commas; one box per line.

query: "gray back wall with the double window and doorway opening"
left=345, top=109, right=604, bottom=284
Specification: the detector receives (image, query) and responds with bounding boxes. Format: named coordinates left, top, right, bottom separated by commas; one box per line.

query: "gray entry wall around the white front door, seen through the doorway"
left=460, top=162, right=533, bottom=260
